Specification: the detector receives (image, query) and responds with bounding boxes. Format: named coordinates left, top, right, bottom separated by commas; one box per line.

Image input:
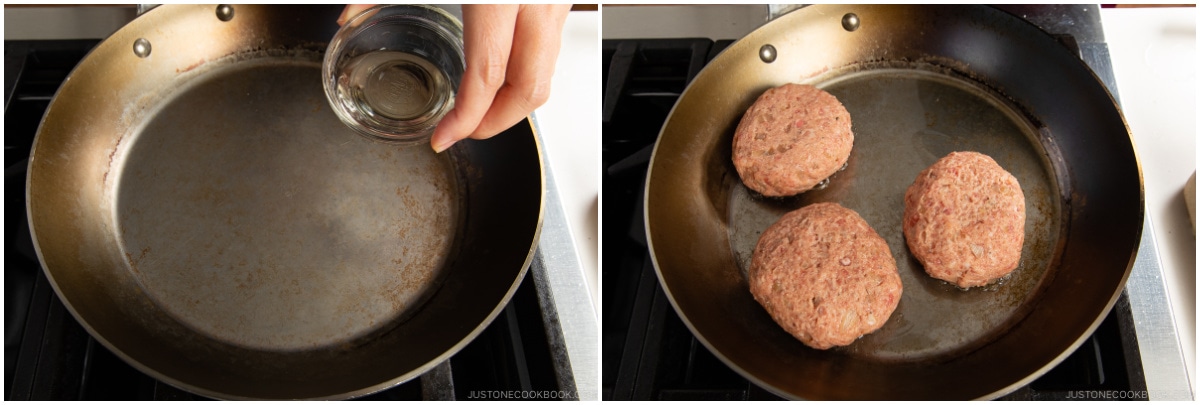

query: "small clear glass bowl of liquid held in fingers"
left=322, top=5, right=466, bottom=144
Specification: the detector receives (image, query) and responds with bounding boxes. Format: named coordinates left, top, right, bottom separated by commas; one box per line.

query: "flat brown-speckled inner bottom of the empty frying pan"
left=117, top=59, right=460, bottom=351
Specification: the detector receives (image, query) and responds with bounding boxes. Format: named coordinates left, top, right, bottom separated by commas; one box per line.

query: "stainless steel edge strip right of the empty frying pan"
left=529, top=114, right=600, bottom=400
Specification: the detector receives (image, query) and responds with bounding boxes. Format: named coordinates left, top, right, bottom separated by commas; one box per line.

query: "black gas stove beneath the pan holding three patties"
left=602, top=7, right=1146, bottom=400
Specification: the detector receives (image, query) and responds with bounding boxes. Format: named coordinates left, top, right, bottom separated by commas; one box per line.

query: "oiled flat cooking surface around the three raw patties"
left=727, top=68, right=1061, bottom=362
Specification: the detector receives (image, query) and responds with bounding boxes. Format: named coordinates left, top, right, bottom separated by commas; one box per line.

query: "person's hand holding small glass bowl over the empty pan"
left=337, top=5, right=571, bottom=152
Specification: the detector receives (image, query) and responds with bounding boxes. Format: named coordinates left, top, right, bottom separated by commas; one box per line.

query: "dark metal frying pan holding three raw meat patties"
left=646, top=5, right=1144, bottom=399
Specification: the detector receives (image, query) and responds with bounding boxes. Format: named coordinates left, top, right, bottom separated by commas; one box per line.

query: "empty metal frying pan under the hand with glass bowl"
left=28, top=5, right=544, bottom=399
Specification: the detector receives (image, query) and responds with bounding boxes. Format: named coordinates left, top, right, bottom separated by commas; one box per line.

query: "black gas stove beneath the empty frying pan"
left=4, top=41, right=562, bottom=400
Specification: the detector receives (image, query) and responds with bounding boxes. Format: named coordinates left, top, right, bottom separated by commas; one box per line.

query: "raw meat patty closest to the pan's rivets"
left=733, top=84, right=854, bottom=197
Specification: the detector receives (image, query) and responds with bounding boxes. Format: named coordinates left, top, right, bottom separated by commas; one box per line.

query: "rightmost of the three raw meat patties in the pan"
left=904, top=152, right=1025, bottom=288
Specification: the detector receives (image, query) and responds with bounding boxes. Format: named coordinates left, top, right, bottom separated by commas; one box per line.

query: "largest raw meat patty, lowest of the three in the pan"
left=749, top=203, right=902, bottom=349
